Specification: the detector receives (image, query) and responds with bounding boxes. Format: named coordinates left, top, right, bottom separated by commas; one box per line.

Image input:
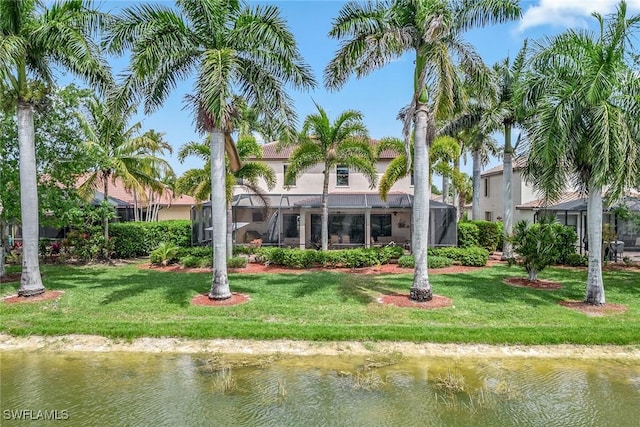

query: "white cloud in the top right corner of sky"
left=518, top=0, right=640, bottom=31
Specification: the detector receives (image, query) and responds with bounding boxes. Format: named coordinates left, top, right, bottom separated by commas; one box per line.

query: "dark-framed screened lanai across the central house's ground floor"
left=191, top=193, right=457, bottom=249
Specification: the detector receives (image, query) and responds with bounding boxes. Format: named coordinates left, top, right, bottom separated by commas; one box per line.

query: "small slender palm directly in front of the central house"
left=284, top=104, right=378, bottom=251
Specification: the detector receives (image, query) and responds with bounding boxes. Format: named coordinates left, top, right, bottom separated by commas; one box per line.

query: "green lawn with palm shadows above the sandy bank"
left=0, top=265, right=640, bottom=345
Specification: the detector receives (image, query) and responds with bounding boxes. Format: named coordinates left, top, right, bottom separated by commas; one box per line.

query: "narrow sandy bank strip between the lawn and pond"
left=0, top=334, right=640, bottom=360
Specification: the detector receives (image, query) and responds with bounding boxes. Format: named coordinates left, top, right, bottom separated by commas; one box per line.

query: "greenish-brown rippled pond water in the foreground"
left=0, top=351, right=640, bottom=427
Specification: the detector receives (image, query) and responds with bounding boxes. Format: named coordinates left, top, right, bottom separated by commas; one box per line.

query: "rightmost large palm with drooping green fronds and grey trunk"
left=525, top=2, right=640, bottom=305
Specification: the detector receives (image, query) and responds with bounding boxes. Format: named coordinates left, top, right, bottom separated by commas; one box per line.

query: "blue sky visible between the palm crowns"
left=91, top=0, right=640, bottom=177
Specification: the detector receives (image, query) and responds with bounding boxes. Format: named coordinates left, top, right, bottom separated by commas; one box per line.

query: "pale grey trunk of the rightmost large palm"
left=585, top=186, right=605, bottom=305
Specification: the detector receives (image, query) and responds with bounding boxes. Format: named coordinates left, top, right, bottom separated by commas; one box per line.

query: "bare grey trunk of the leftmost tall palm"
left=18, top=101, right=45, bottom=297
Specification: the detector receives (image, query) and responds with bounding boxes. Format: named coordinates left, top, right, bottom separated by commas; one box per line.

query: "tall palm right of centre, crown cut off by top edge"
left=325, top=0, right=521, bottom=301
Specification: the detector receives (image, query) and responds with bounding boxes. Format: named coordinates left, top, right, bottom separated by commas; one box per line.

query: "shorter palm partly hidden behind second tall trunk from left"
left=176, top=134, right=276, bottom=258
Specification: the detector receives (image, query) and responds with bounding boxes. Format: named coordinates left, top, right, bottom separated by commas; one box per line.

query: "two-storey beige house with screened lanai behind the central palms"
left=192, top=143, right=457, bottom=248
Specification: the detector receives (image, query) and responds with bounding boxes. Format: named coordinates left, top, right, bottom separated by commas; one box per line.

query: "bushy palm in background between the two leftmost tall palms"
left=79, top=97, right=173, bottom=246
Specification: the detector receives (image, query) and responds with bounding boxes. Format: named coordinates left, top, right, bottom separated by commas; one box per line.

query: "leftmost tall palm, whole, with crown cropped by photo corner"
left=0, top=0, right=111, bottom=297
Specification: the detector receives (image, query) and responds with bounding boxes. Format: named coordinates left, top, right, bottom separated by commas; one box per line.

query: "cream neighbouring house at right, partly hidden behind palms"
left=480, top=157, right=640, bottom=252
